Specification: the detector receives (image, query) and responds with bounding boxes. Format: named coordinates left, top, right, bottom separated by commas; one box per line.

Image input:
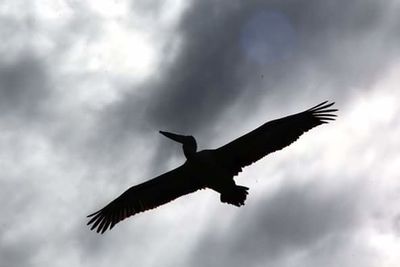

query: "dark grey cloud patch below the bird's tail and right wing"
left=188, top=180, right=362, bottom=266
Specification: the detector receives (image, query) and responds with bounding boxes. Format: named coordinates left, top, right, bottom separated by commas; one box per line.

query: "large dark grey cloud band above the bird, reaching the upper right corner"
left=100, top=0, right=400, bottom=173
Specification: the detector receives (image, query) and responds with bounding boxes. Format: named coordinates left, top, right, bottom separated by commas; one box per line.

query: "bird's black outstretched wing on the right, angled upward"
left=216, top=101, right=337, bottom=175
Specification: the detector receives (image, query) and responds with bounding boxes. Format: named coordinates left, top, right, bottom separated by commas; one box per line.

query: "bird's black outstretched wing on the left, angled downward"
left=87, top=164, right=204, bottom=236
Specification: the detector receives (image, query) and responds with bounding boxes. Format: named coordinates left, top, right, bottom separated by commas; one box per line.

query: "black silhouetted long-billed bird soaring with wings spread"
left=87, top=101, right=338, bottom=234
